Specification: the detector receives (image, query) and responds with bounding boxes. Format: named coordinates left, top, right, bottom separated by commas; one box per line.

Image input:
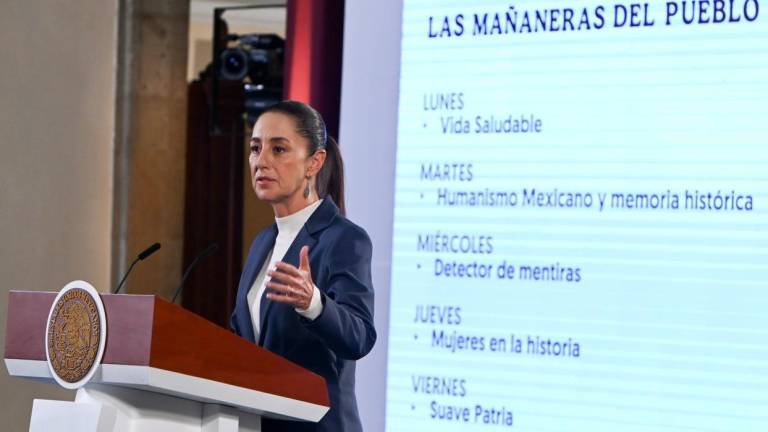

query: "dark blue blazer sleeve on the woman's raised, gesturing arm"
left=302, top=227, right=376, bottom=360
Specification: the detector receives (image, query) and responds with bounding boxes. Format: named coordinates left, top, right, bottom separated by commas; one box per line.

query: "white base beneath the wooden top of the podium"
left=29, top=384, right=261, bottom=432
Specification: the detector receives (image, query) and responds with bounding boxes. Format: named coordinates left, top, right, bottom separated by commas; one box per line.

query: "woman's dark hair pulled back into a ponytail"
left=257, top=100, right=346, bottom=215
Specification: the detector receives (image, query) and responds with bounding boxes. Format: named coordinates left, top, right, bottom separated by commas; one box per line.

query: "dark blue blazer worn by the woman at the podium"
left=231, top=197, right=376, bottom=432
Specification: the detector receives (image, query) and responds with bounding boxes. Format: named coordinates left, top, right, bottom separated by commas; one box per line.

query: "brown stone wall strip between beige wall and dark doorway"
left=121, top=0, right=189, bottom=299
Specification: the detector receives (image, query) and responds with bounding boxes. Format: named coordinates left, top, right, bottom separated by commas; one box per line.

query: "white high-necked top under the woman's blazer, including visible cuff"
left=248, top=200, right=323, bottom=340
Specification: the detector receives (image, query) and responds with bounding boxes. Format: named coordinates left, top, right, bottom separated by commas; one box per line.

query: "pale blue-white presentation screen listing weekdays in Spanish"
left=386, top=0, right=768, bottom=432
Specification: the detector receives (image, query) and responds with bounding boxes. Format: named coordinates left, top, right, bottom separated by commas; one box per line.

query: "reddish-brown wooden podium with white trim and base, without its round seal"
left=5, top=291, right=330, bottom=432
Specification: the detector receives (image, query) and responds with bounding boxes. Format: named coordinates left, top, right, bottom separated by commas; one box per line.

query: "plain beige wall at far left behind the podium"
left=0, top=0, right=117, bottom=431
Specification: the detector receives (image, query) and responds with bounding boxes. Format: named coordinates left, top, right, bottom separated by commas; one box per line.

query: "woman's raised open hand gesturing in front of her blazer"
left=266, top=246, right=315, bottom=310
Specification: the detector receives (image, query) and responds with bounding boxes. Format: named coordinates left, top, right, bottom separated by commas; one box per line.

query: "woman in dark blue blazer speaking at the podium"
left=231, top=101, right=376, bottom=431
